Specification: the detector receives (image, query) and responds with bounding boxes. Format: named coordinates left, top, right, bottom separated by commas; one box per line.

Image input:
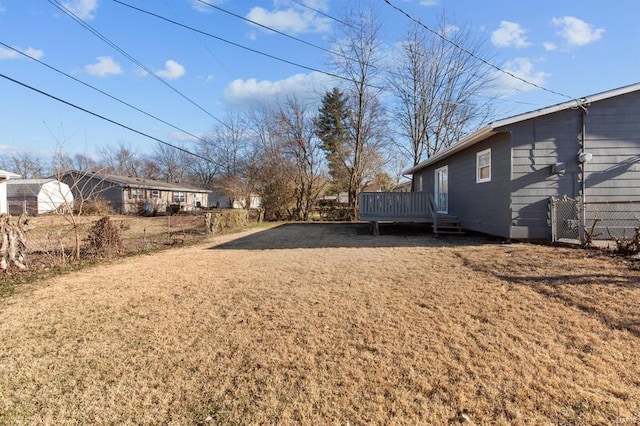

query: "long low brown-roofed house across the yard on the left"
left=61, top=171, right=211, bottom=213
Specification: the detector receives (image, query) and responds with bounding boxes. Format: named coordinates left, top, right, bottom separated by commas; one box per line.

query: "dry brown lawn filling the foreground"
left=0, top=224, right=640, bottom=425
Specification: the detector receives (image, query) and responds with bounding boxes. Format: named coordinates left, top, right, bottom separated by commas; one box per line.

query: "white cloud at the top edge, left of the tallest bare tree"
left=246, top=1, right=331, bottom=34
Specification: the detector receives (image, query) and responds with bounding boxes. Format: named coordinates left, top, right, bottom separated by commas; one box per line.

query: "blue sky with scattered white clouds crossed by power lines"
left=0, top=0, right=640, bottom=158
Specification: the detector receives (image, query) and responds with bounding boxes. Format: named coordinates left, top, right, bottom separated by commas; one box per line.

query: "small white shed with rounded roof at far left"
left=7, top=179, right=73, bottom=216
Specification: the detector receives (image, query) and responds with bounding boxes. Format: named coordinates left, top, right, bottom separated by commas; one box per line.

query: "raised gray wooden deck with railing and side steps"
left=358, top=192, right=461, bottom=234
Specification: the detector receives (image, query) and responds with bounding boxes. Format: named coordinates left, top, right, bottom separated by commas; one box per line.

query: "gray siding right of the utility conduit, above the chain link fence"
left=585, top=92, right=640, bottom=202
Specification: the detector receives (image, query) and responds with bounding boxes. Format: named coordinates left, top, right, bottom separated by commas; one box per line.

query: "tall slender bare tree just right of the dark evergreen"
left=333, top=8, right=386, bottom=218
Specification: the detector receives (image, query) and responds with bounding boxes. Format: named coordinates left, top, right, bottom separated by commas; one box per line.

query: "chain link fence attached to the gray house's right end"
left=549, top=197, right=640, bottom=248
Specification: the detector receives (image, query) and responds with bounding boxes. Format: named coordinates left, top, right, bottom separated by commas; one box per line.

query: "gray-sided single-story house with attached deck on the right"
left=404, top=83, right=640, bottom=239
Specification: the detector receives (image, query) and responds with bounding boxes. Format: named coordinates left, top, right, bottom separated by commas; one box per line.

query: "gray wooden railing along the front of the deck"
left=358, top=192, right=433, bottom=222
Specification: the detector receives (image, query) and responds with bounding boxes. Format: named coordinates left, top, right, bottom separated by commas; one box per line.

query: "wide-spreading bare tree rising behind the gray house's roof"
left=389, top=15, right=494, bottom=165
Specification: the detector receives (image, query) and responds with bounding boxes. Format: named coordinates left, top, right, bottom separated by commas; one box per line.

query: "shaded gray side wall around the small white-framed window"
left=415, top=133, right=511, bottom=238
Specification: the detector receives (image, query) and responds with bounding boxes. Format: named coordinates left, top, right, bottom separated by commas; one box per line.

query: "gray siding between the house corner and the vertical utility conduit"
left=508, top=110, right=581, bottom=239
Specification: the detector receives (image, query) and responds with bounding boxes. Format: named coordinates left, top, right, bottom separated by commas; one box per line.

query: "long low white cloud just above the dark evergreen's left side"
left=224, top=72, right=335, bottom=108
